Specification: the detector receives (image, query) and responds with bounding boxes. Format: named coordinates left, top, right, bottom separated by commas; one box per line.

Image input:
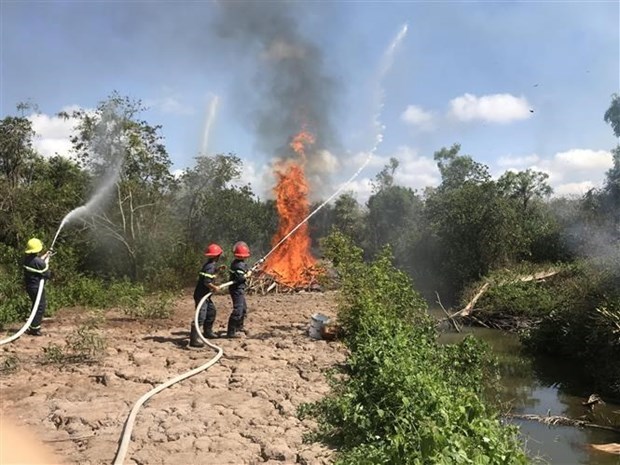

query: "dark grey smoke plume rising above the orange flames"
left=216, top=2, right=338, bottom=178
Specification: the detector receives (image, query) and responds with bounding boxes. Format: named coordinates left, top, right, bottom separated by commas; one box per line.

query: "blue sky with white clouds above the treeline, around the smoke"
left=0, top=0, right=620, bottom=199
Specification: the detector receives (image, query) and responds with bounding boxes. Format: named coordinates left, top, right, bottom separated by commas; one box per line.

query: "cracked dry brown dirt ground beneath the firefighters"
left=0, top=291, right=346, bottom=465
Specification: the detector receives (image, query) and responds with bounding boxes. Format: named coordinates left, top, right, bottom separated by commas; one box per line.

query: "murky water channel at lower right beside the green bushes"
left=441, top=328, right=620, bottom=465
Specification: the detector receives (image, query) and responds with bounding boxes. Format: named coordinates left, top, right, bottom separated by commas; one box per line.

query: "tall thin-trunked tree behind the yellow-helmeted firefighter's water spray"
left=65, top=93, right=177, bottom=280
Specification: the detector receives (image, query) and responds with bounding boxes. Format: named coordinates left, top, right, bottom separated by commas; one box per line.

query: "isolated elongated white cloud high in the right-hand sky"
left=449, top=94, right=532, bottom=124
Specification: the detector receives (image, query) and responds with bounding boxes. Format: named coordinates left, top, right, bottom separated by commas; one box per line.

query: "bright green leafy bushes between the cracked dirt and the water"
left=301, top=233, right=527, bottom=465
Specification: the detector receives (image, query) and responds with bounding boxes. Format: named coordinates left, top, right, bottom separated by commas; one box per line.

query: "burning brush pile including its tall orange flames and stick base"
left=249, top=130, right=323, bottom=294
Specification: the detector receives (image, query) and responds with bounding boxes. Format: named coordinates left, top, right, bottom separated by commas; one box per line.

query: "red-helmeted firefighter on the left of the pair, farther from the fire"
left=189, top=244, right=222, bottom=347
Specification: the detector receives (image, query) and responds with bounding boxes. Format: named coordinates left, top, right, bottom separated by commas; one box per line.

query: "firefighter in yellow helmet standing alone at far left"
left=24, top=237, right=51, bottom=336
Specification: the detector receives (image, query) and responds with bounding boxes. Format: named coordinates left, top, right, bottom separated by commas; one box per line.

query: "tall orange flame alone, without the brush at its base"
left=264, top=130, right=316, bottom=286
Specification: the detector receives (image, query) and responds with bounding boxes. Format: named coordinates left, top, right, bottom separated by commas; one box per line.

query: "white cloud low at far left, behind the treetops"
left=28, top=106, right=78, bottom=158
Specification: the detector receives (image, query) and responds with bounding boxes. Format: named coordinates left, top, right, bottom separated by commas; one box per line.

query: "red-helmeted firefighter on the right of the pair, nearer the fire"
left=226, top=241, right=252, bottom=338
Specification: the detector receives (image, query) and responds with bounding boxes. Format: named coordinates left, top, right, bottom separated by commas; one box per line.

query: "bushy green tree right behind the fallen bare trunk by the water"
left=425, top=144, right=527, bottom=298
